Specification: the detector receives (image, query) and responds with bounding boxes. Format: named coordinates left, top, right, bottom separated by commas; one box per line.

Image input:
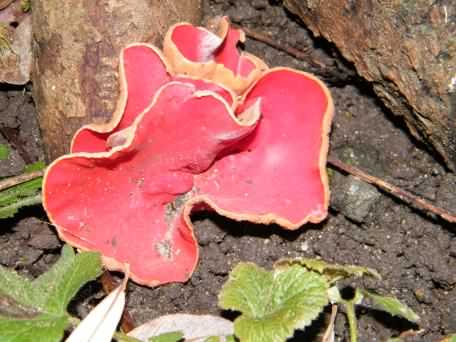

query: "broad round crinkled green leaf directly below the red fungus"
left=219, top=263, right=328, bottom=342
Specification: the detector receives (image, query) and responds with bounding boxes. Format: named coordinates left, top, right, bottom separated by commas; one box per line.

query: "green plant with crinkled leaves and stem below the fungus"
left=219, top=258, right=419, bottom=342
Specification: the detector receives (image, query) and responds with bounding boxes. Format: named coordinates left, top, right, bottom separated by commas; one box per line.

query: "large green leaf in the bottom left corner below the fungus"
left=0, top=246, right=101, bottom=342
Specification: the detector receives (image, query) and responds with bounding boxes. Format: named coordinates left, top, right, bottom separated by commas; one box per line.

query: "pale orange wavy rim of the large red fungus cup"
left=43, top=67, right=334, bottom=287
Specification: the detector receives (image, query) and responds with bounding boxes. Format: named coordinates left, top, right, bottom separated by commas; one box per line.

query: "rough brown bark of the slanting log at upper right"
left=284, top=0, right=456, bottom=170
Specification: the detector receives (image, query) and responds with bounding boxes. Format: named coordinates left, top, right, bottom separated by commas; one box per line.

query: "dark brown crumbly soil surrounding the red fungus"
left=0, top=0, right=456, bottom=341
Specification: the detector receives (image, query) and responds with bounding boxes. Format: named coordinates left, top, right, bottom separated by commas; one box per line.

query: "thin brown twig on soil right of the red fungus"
left=328, top=158, right=456, bottom=223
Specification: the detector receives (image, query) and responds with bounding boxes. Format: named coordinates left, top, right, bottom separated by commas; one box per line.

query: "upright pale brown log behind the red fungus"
left=32, top=0, right=201, bottom=160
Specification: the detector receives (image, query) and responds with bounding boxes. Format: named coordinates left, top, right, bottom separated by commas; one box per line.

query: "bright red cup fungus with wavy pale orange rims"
left=43, top=18, right=333, bottom=286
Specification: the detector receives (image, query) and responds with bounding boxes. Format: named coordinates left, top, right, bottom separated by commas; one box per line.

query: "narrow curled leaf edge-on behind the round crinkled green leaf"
left=275, top=258, right=382, bottom=283
